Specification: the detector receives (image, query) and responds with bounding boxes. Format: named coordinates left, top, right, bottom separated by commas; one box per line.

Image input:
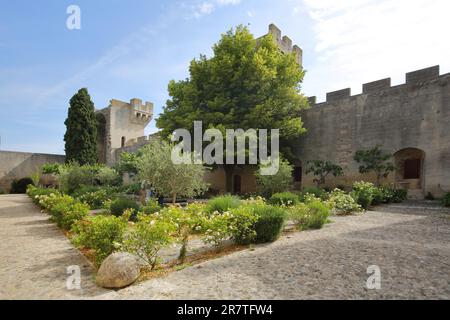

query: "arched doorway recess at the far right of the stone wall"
left=394, top=148, right=425, bottom=191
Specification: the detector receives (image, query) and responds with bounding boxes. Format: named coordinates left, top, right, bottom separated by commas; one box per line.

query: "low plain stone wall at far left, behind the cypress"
left=0, top=151, right=65, bottom=192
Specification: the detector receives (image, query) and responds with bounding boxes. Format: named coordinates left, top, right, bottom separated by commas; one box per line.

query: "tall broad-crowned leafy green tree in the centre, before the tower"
left=156, top=26, right=308, bottom=191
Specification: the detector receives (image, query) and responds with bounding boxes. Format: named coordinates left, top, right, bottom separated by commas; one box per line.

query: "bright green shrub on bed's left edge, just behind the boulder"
left=72, top=216, right=128, bottom=266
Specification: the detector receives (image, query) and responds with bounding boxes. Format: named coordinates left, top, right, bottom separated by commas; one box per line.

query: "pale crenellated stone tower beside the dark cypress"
left=97, top=98, right=153, bottom=166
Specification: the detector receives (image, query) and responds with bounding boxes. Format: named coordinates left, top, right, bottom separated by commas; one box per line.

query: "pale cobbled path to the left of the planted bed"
left=0, top=195, right=108, bottom=300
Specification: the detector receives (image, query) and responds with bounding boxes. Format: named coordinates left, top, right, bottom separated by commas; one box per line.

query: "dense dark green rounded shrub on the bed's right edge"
left=254, top=205, right=286, bottom=243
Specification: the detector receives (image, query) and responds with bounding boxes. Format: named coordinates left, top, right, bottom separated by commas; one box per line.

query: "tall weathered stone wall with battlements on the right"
left=297, top=66, right=450, bottom=195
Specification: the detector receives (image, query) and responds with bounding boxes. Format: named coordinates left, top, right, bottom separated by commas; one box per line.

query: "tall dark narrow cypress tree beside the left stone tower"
left=64, top=88, right=98, bottom=165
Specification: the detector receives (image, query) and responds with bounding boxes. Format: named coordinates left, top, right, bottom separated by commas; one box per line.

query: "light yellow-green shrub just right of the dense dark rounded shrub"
left=289, top=200, right=330, bottom=230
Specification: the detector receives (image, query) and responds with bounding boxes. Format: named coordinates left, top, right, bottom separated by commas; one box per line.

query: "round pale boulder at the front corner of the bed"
left=96, top=252, right=142, bottom=289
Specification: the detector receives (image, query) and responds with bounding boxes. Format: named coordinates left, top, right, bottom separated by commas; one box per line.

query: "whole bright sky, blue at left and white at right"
left=0, top=0, right=450, bottom=153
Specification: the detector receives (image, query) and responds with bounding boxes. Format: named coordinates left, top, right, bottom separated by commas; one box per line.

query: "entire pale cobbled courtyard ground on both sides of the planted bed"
left=0, top=196, right=450, bottom=299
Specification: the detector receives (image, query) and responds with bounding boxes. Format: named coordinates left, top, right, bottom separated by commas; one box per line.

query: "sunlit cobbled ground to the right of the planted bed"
left=100, top=202, right=450, bottom=299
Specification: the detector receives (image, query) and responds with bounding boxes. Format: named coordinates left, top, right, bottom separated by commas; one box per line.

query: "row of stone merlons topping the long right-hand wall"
left=308, top=66, right=444, bottom=105
